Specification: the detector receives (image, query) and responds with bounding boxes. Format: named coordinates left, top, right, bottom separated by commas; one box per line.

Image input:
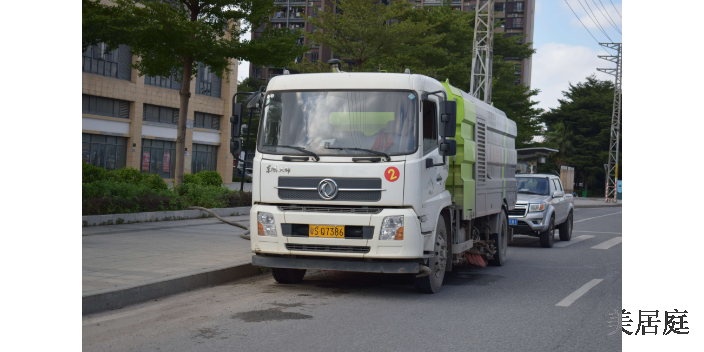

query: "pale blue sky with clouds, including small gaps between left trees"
left=237, top=0, right=623, bottom=110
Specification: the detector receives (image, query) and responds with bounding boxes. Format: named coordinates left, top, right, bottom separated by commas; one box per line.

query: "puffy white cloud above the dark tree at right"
left=531, top=43, right=614, bottom=111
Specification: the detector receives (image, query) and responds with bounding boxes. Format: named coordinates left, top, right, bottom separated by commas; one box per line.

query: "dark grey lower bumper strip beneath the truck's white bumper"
left=252, top=255, right=420, bottom=274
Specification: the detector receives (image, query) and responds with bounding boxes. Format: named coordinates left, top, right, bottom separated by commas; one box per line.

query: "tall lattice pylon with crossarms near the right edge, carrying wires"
left=597, top=43, right=623, bottom=203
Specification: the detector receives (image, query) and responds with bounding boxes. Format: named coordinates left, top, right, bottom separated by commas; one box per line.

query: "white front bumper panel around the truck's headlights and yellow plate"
left=250, top=204, right=426, bottom=258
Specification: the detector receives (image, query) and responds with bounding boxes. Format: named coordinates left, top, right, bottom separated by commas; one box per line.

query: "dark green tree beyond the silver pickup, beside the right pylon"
left=540, top=75, right=623, bottom=194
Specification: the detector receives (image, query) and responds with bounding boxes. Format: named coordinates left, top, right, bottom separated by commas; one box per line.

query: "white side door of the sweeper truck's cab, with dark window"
left=421, top=96, right=447, bottom=231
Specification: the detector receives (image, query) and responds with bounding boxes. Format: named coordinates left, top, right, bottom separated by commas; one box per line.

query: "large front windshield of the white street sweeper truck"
left=257, top=91, right=418, bottom=156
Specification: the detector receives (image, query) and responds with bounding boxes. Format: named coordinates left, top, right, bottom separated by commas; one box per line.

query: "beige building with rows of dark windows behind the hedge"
left=81, top=44, right=238, bottom=183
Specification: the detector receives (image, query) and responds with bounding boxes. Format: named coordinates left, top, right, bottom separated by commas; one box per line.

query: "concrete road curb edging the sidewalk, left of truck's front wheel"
left=81, top=263, right=259, bottom=315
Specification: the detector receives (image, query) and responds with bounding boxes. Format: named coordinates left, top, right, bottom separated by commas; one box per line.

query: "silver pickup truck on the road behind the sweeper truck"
left=508, top=174, right=574, bottom=248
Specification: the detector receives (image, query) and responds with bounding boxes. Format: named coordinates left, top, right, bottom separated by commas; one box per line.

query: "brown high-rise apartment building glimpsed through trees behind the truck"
left=249, top=0, right=535, bottom=87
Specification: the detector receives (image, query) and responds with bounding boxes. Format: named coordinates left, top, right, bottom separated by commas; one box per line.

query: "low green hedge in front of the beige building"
left=81, top=161, right=252, bottom=215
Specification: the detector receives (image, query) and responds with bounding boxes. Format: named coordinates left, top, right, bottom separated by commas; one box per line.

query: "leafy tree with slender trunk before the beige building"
left=81, top=0, right=308, bottom=185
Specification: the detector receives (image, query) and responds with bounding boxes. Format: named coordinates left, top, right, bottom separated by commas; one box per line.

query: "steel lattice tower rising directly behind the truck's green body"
left=470, top=0, right=494, bottom=104
